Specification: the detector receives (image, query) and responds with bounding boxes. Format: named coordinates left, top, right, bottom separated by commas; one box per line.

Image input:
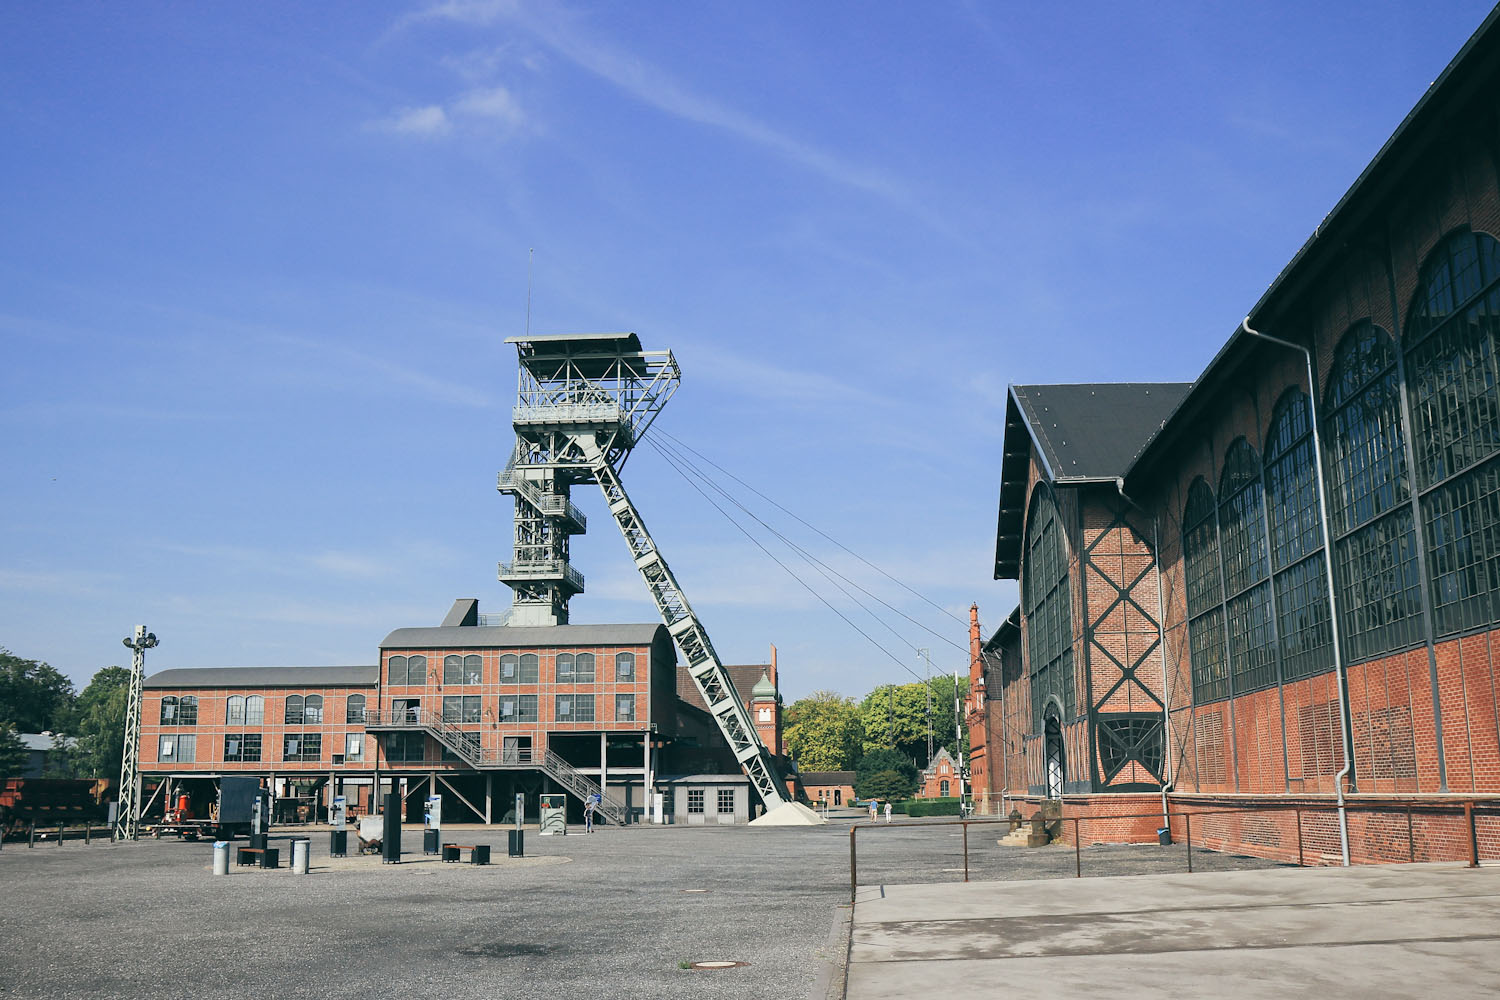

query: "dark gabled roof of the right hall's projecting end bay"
left=995, top=382, right=1193, bottom=580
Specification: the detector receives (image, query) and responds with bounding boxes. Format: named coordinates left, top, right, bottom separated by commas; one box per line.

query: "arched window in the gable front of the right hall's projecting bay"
left=1022, top=484, right=1076, bottom=733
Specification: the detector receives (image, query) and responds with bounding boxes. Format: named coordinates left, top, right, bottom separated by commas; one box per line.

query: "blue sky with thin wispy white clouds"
left=0, top=0, right=1488, bottom=697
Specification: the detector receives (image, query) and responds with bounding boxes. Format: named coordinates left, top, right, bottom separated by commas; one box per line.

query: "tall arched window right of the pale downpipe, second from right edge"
left=1325, top=319, right=1422, bottom=660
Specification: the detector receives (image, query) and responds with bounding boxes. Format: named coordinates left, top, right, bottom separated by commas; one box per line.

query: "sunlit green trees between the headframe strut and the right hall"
left=783, top=676, right=969, bottom=799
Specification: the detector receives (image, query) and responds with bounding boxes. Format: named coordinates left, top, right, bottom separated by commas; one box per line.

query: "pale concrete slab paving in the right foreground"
left=848, top=865, right=1500, bottom=1000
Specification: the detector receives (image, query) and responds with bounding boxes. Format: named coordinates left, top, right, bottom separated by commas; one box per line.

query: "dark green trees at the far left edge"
left=0, top=646, right=131, bottom=778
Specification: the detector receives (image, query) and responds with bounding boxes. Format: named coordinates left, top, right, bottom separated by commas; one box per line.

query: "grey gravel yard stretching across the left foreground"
left=0, top=819, right=1269, bottom=1000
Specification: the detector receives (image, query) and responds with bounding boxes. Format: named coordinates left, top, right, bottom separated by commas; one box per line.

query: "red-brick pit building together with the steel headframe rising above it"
left=123, top=326, right=816, bottom=829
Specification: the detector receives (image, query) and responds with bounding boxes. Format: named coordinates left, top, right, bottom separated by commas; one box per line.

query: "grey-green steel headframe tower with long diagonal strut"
left=500, top=333, right=785, bottom=811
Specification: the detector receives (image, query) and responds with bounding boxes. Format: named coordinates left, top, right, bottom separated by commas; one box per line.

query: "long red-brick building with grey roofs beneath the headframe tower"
left=140, top=600, right=786, bottom=823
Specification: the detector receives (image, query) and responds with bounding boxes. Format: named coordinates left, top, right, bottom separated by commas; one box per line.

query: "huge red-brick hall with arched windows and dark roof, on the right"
left=969, top=12, right=1500, bottom=862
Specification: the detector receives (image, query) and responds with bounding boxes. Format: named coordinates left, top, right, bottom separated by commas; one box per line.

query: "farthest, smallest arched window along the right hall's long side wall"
left=1182, top=477, right=1229, bottom=705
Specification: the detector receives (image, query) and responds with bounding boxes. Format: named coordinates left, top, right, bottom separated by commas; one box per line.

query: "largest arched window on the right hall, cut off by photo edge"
left=1404, top=229, right=1500, bottom=636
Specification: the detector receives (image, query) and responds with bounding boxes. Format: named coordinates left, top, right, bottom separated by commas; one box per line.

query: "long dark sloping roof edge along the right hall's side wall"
left=1127, top=6, right=1500, bottom=493
